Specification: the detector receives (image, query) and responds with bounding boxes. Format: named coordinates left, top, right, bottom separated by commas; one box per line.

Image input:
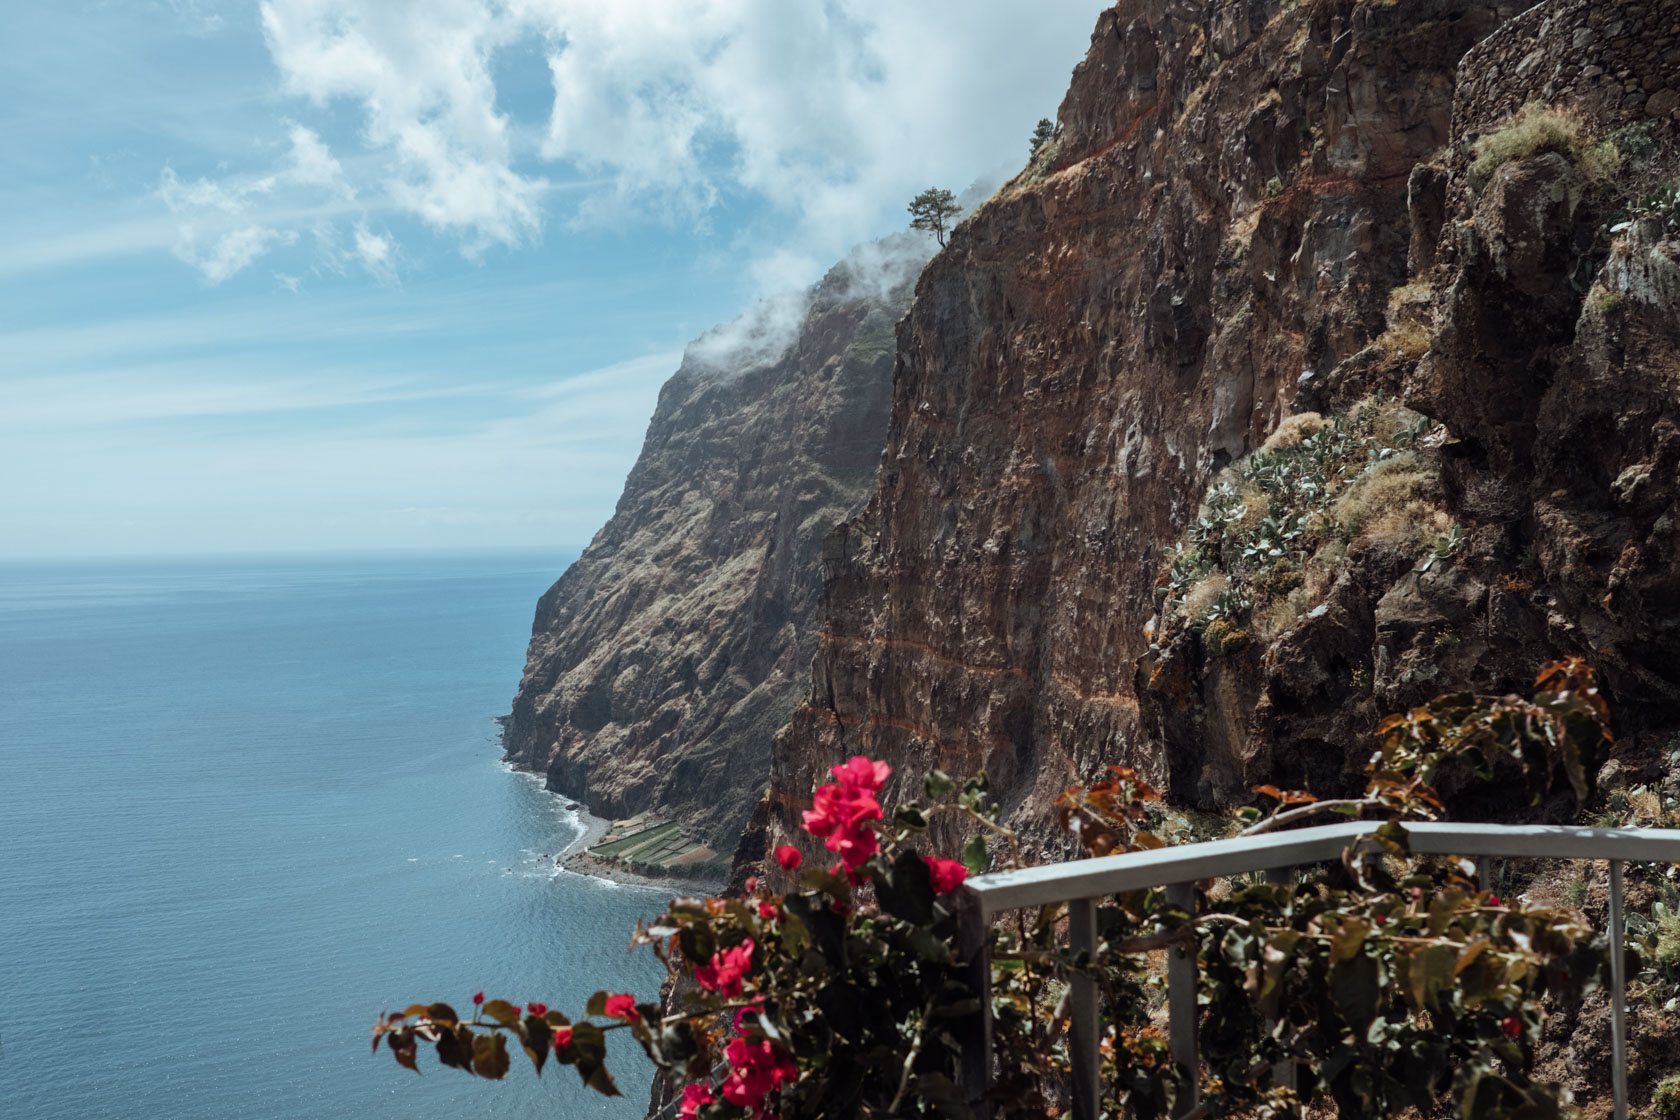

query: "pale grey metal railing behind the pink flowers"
left=961, top=821, right=1680, bottom=1120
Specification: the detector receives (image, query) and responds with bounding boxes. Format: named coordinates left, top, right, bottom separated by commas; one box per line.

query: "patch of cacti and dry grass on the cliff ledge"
left=1156, top=398, right=1457, bottom=653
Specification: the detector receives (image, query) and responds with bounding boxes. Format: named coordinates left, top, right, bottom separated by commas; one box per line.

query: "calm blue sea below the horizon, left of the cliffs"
left=0, top=554, right=665, bottom=1120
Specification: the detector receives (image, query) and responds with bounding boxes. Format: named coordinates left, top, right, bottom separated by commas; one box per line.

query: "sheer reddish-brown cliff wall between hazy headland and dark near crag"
left=754, top=0, right=1522, bottom=866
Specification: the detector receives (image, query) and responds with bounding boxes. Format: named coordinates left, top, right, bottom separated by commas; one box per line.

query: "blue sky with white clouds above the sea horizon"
left=0, top=0, right=1104, bottom=557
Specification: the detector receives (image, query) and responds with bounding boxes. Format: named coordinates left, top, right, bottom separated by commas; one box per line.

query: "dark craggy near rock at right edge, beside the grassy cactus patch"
left=1139, top=0, right=1680, bottom=816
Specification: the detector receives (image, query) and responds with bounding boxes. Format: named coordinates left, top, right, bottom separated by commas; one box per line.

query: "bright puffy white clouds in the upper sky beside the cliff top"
left=160, top=0, right=1102, bottom=290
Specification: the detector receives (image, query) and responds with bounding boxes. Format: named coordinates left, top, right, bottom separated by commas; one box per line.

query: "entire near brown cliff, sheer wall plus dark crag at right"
left=738, top=0, right=1680, bottom=871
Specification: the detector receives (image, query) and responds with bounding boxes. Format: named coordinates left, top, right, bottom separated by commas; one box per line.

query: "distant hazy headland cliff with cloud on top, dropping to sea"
left=504, top=237, right=926, bottom=856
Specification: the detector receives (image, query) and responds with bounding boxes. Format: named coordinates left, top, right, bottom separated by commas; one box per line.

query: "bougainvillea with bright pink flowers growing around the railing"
left=373, top=662, right=1608, bottom=1120
